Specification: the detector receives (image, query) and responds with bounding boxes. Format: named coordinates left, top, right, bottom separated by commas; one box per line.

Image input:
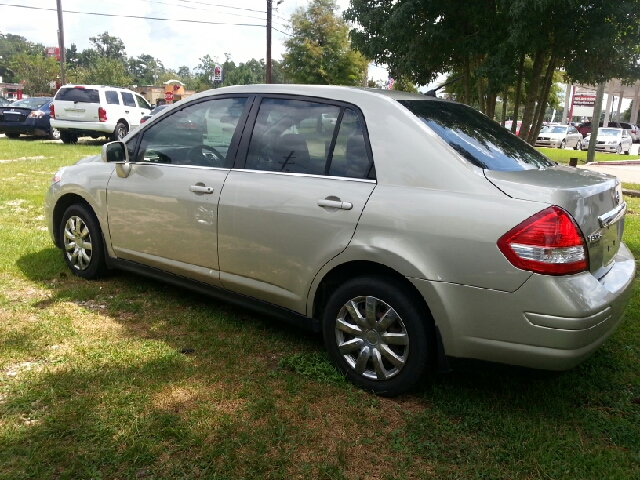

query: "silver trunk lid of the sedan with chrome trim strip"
left=485, top=166, right=625, bottom=278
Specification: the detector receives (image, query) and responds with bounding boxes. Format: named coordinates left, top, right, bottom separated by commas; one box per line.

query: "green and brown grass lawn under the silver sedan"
left=0, top=138, right=640, bottom=480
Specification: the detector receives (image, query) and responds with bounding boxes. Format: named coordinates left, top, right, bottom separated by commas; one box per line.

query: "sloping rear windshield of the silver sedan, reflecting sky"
left=399, top=100, right=555, bottom=172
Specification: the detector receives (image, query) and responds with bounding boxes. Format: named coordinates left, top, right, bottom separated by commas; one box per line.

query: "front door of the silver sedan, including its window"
left=107, top=96, right=248, bottom=285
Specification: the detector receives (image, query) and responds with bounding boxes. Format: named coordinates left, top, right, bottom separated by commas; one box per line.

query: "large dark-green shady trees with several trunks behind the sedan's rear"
left=345, top=0, right=640, bottom=142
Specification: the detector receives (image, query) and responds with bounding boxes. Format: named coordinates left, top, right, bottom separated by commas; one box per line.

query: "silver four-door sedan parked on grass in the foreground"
left=45, top=85, right=635, bottom=395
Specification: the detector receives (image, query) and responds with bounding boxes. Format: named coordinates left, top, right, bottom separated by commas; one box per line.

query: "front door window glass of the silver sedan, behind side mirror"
left=136, top=98, right=247, bottom=168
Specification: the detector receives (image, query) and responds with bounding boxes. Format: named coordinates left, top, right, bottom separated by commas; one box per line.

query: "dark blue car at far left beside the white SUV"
left=0, top=97, right=60, bottom=140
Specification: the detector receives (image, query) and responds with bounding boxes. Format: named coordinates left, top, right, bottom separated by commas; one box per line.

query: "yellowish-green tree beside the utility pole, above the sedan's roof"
left=282, top=0, right=368, bottom=85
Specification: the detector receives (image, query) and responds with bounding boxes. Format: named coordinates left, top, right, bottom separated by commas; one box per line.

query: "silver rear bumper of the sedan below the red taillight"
left=412, top=244, right=635, bottom=370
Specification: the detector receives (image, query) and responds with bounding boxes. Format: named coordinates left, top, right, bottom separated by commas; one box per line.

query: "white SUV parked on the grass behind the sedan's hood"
left=51, top=85, right=151, bottom=143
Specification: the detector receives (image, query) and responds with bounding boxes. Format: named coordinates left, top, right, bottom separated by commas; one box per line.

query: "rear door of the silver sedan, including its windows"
left=218, top=97, right=376, bottom=314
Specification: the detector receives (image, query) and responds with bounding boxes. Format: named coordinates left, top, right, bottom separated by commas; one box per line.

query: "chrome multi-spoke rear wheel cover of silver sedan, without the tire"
left=335, top=296, right=409, bottom=380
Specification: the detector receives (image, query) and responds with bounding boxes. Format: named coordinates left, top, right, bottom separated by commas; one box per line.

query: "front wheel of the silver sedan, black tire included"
left=59, top=204, right=107, bottom=279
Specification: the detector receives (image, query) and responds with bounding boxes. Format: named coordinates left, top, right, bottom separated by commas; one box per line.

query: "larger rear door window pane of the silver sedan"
left=245, top=99, right=340, bottom=175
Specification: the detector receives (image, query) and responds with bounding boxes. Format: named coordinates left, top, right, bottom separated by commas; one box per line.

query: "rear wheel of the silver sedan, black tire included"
left=322, top=277, right=435, bottom=397
